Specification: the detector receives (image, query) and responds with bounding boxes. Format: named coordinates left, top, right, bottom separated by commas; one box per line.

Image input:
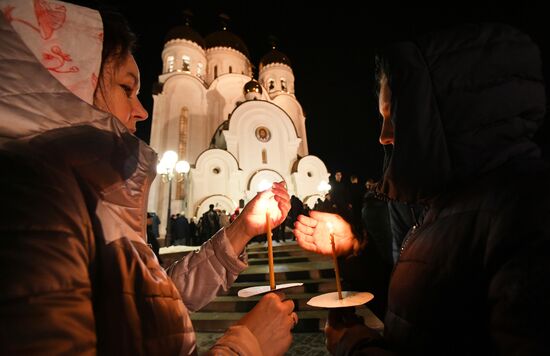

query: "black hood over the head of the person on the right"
left=378, top=24, right=546, bottom=202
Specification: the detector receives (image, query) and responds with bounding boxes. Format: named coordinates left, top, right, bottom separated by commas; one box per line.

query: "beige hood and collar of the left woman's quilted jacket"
left=0, top=6, right=157, bottom=243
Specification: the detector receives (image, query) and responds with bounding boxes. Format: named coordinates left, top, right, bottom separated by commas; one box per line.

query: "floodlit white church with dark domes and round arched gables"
left=148, top=25, right=329, bottom=232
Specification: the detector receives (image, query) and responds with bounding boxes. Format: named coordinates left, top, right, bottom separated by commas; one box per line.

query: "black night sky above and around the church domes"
left=108, top=0, right=550, bottom=181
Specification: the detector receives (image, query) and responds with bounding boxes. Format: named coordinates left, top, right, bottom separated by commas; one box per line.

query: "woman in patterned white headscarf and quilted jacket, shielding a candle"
left=0, top=0, right=297, bottom=355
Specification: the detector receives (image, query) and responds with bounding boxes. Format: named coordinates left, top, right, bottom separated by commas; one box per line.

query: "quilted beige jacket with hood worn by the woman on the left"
left=0, top=10, right=261, bottom=355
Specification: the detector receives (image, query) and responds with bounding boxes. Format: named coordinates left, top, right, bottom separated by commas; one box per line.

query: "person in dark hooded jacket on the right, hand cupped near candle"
left=294, top=24, right=550, bottom=355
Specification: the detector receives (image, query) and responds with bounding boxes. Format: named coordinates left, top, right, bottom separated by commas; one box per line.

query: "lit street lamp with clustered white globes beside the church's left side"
left=157, top=151, right=191, bottom=246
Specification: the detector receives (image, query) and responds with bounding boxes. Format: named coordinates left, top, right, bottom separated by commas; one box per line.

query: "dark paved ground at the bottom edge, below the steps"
left=197, top=332, right=330, bottom=356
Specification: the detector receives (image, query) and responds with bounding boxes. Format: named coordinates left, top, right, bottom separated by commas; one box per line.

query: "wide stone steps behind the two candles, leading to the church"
left=191, top=241, right=383, bottom=333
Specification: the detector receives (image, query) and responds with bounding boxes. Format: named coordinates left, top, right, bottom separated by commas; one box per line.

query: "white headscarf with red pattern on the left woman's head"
left=0, top=0, right=103, bottom=104
